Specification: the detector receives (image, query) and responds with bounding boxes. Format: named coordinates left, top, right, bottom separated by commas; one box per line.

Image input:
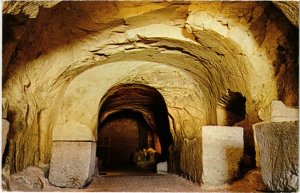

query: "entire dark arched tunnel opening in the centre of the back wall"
left=96, top=84, right=173, bottom=175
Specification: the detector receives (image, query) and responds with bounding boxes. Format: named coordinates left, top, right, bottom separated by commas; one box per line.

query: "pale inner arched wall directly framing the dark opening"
left=54, top=61, right=209, bottom=177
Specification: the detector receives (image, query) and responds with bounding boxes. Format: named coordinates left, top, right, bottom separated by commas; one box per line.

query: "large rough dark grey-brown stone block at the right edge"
left=255, top=121, right=299, bottom=191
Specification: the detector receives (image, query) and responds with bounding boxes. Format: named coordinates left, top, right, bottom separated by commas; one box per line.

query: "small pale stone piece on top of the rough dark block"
left=271, top=101, right=299, bottom=122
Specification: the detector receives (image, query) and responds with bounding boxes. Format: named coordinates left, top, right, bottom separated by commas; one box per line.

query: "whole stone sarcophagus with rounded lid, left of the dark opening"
left=49, top=121, right=96, bottom=188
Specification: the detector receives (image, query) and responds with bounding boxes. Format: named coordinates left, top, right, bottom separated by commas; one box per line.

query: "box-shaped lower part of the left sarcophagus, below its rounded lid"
left=49, top=141, right=96, bottom=188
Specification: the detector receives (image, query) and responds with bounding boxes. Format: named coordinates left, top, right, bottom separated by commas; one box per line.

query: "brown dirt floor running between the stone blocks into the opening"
left=44, top=165, right=266, bottom=192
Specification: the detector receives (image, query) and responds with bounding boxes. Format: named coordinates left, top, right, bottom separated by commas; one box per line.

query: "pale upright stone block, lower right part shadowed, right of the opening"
left=202, top=126, right=244, bottom=185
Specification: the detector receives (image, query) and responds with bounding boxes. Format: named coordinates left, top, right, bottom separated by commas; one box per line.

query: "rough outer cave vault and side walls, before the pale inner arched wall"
left=3, top=2, right=295, bottom=179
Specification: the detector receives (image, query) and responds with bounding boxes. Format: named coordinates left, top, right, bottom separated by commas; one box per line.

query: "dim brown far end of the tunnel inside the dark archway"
left=97, top=110, right=160, bottom=166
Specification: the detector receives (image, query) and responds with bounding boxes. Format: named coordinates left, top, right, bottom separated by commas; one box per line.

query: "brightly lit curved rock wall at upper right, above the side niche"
left=186, top=2, right=298, bottom=156
